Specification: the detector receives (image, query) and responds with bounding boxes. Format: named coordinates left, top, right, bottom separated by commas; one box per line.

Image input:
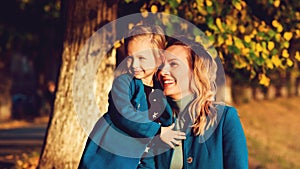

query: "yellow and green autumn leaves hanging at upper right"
left=126, top=0, right=300, bottom=86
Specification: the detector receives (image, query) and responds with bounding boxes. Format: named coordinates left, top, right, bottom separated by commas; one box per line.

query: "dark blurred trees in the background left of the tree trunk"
left=0, top=0, right=64, bottom=120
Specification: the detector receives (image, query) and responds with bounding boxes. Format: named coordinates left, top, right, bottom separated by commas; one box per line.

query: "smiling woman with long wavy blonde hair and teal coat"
left=152, top=39, right=248, bottom=169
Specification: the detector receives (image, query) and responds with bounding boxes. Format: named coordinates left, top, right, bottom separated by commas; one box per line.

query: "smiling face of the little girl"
left=127, top=39, right=157, bottom=86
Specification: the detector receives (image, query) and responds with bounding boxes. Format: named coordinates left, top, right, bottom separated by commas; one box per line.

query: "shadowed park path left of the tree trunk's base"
left=0, top=123, right=47, bottom=169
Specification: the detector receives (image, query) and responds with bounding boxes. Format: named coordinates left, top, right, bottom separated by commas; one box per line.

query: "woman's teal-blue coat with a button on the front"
left=140, top=105, right=248, bottom=169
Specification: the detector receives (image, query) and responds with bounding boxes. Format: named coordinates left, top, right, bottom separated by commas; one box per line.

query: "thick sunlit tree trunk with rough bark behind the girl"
left=39, top=0, right=117, bottom=169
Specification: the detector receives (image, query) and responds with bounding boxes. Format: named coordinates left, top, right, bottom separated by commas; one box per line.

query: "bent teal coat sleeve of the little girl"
left=108, top=75, right=160, bottom=138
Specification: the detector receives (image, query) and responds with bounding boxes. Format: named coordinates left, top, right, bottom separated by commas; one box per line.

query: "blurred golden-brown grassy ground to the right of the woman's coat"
left=236, top=97, right=300, bottom=169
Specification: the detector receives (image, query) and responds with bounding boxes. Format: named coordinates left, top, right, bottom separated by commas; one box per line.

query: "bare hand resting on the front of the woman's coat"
left=159, top=123, right=186, bottom=148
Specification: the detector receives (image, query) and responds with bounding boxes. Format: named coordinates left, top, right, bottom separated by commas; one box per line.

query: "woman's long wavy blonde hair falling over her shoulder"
left=168, top=39, right=217, bottom=135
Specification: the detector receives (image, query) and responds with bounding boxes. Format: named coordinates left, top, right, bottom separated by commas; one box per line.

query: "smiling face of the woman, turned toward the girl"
left=158, top=45, right=193, bottom=100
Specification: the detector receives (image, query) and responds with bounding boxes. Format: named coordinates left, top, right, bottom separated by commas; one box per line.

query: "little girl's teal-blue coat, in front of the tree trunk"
left=78, top=74, right=173, bottom=169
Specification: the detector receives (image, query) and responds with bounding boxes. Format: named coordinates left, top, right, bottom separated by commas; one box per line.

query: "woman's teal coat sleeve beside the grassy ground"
left=223, top=107, right=248, bottom=169
